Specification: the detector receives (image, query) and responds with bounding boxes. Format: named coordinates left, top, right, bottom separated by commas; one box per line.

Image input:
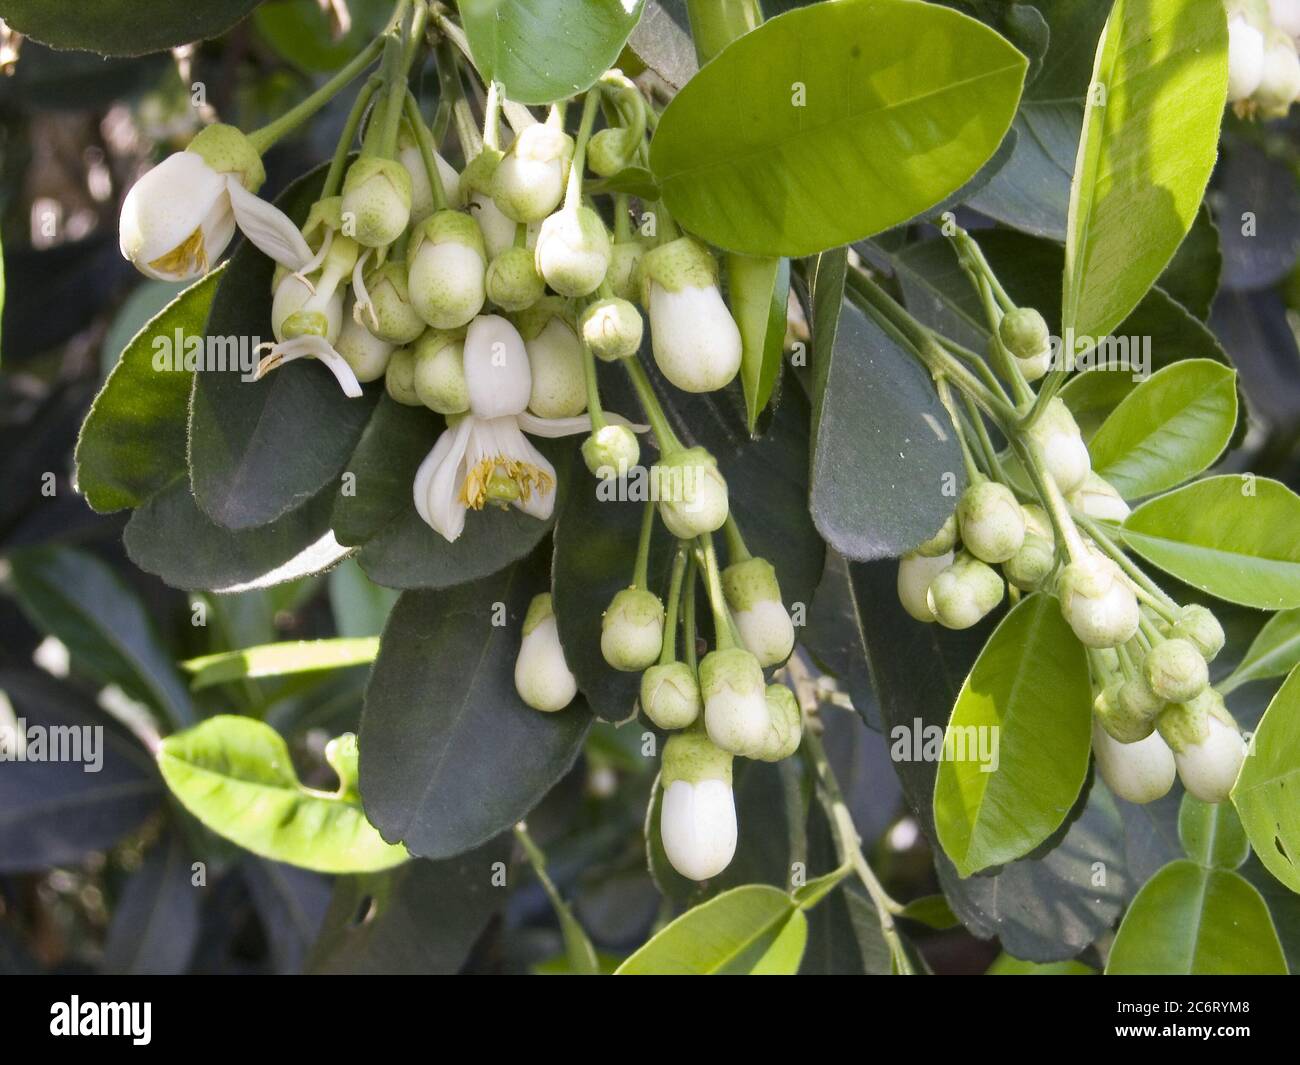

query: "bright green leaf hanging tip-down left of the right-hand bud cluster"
left=935, top=594, right=1092, bottom=876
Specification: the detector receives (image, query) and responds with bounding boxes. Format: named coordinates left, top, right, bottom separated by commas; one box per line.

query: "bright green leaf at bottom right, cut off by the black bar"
left=1106, top=858, right=1287, bottom=977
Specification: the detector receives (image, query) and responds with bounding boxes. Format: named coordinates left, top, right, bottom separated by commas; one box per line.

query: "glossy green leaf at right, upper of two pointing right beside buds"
left=1088, top=359, right=1236, bottom=499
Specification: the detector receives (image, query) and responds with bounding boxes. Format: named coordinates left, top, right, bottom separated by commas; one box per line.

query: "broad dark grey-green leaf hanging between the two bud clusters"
left=809, top=248, right=965, bottom=560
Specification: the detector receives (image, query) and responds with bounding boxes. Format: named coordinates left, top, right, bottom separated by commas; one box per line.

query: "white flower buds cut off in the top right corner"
left=1227, top=0, right=1300, bottom=118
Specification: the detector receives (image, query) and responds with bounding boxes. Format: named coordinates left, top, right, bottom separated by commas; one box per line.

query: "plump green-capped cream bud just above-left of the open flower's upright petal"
left=407, top=211, right=488, bottom=329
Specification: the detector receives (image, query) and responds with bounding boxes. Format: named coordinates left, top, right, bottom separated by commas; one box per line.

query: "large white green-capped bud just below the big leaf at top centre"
left=641, top=237, right=741, bottom=393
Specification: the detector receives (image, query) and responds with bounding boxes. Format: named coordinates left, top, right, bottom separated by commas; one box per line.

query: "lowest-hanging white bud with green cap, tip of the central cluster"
left=659, top=731, right=736, bottom=880
